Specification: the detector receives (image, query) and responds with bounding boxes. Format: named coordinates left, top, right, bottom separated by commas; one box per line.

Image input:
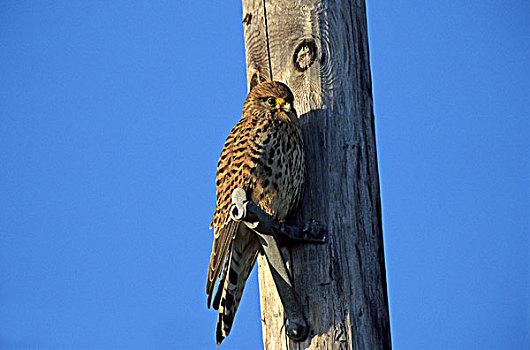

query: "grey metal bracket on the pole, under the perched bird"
left=230, top=188, right=326, bottom=341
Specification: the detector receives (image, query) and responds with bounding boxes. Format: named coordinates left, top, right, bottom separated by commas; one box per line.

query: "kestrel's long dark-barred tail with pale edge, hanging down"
left=213, top=225, right=260, bottom=345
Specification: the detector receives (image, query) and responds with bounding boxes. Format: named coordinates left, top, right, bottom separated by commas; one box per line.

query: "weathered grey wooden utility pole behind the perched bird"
left=243, top=0, right=391, bottom=350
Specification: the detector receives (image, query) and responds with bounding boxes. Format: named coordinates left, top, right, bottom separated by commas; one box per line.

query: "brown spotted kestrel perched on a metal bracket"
left=206, top=81, right=305, bottom=345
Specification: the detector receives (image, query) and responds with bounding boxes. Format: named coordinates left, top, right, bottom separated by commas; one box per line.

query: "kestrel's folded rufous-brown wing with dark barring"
left=206, top=118, right=258, bottom=307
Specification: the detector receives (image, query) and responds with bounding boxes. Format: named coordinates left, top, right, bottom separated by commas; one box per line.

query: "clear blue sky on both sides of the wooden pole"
left=0, top=0, right=530, bottom=349
